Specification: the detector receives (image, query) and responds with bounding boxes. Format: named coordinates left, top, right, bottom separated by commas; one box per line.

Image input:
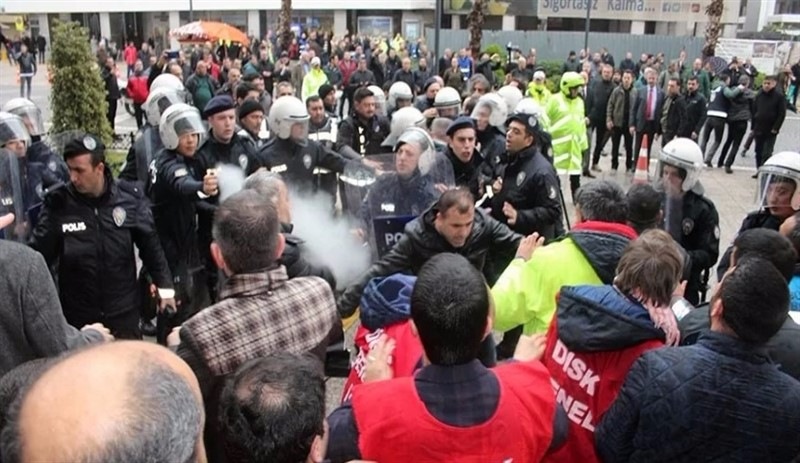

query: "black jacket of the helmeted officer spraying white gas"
left=148, top=149, right=205, bottom=278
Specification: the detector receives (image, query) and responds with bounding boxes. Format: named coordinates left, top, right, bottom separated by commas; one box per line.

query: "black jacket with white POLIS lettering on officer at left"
left=30, top=170, right=173, bottom=328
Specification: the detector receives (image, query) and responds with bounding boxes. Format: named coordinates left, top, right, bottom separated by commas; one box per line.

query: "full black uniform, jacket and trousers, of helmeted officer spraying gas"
left=149, top=150, right=210, bottom=342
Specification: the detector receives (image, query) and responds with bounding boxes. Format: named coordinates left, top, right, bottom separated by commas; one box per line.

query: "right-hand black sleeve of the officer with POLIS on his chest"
left=133, top=190, right=172, bottom=289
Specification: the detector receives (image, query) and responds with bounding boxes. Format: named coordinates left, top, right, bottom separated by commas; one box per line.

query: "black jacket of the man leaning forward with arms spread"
left=339, top=206, right=522, bottom=317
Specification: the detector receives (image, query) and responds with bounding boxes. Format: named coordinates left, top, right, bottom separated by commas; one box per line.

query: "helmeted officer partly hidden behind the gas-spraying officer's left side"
left=119, top=86, right=184, bottom=185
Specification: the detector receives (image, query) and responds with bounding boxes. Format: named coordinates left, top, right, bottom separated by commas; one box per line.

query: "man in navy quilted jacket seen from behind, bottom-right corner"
left=595, top=256, right=800, bottom=462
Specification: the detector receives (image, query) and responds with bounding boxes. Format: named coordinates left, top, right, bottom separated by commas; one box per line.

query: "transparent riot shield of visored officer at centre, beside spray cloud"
left=343, top=151, right=455, bottom=258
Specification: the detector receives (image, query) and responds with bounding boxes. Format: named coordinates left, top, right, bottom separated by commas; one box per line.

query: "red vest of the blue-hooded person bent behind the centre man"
left=342, top=321, right=422, bottom=403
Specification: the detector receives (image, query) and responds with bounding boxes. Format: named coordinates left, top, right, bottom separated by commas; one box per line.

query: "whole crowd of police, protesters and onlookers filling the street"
left=0, top=28, right=800, bottom=462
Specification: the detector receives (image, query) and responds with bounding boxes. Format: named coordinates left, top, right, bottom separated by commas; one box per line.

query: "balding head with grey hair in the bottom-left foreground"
left=2, top=342, right=205, bottom=462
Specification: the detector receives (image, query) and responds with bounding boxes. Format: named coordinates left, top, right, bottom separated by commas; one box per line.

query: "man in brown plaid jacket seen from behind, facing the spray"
left=178, top=190, right=341, bottom=397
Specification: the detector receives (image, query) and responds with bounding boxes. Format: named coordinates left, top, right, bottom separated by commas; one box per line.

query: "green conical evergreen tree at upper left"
left=49, top=20, right=113, bottom=144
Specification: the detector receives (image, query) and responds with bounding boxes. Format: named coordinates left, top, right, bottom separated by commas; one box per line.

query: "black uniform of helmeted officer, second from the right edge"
left=673, top=191, right=719, bottom=305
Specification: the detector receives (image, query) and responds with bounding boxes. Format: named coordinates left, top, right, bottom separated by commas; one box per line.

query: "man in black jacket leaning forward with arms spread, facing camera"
left=339, top=188, right=522, bottom=317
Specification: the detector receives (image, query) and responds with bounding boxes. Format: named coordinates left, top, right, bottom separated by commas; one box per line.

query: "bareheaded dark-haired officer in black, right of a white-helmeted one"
left=336, top=87, right=390, bottom=159
